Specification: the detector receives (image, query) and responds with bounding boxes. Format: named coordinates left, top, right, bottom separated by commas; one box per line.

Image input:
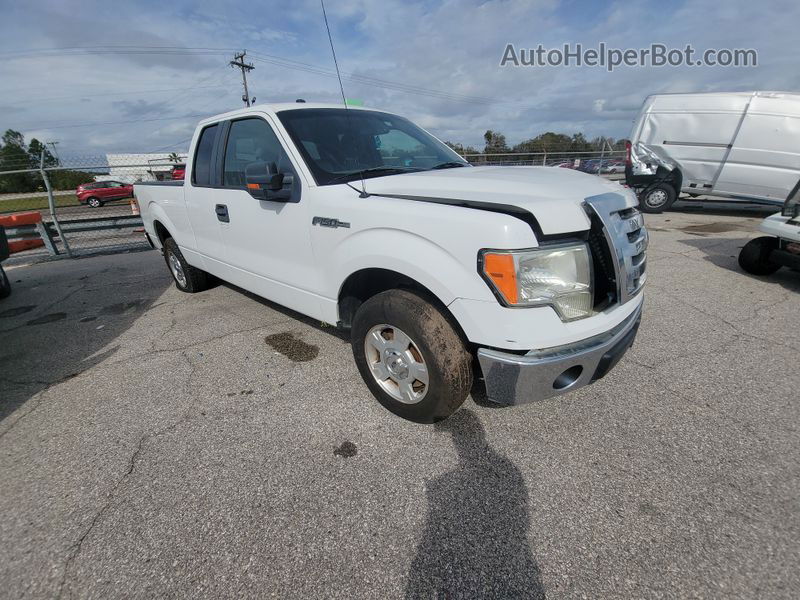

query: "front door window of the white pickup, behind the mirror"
left=223, top=118, right=293, bottom=188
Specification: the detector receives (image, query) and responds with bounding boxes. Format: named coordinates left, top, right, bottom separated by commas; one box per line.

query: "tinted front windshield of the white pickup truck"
left=278, top=108, right=469, bottom=185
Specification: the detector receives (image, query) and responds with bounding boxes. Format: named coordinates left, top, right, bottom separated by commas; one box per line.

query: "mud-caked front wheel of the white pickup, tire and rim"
left=351, top=289, right=472, bottom=423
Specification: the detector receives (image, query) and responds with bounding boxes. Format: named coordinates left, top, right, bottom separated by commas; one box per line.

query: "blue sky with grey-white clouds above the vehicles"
left=0, top=0, right=800, bottom=155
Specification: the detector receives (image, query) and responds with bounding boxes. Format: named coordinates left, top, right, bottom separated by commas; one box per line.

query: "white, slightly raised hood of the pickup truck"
left=360, top=167, right=636, bottom=235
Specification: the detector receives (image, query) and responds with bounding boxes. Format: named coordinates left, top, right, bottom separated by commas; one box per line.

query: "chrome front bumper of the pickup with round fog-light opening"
left=478, top=305, right=642, bottom=404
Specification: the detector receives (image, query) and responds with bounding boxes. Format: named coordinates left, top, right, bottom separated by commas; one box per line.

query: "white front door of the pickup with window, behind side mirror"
left=216, top=116, right=319, bottom=315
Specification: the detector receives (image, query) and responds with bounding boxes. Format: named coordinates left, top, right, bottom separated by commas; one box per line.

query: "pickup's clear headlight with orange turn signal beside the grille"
left=479, top=243, right=594, bottom=321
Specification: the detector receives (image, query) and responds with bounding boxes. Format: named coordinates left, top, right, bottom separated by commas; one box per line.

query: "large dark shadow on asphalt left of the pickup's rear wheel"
left=0, top=255, right=172, bottom=422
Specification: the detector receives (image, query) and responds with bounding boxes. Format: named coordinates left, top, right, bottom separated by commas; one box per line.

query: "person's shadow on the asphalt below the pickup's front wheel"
left=405, top=409, right=545, bottom=599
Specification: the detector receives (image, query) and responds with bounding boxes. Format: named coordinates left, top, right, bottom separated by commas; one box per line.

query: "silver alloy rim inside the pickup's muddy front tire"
left=364, top=323, right=429, bottom=404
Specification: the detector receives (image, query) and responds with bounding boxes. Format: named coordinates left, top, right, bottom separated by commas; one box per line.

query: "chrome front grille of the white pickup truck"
left=586, top=193, right=648, bottom=304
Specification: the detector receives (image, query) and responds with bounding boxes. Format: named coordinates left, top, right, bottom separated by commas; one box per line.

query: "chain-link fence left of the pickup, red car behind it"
left=0, top=153, right=186, bottom=259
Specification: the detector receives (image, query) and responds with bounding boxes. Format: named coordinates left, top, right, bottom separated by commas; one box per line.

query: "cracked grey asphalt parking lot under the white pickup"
left=0, top=206, right=800, bottom=598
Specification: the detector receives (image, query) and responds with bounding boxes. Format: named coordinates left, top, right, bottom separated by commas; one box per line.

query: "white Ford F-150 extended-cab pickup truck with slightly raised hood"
left=134, top=103, right=648, bottom=423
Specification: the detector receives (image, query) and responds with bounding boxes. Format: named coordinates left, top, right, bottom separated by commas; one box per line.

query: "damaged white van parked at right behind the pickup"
left=625, top=92, right=800, bottom=212
